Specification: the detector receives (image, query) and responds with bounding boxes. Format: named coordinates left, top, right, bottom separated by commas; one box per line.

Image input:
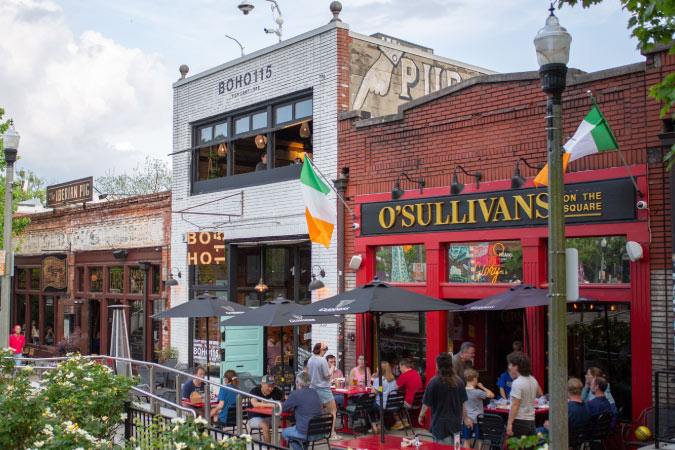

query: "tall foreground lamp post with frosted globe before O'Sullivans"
left=534, top=6, right=572, bottom=449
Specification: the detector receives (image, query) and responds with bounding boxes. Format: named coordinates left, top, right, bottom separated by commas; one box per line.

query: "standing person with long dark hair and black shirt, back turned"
left=418, top=353, right=473, bottom=445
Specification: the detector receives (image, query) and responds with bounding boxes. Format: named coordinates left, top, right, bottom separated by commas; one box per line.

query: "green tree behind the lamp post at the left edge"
left=0, top=108, right=45, bottom=248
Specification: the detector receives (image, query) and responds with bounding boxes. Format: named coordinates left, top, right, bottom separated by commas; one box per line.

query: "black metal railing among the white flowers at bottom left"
left=124, top=401, right=288, bottom=450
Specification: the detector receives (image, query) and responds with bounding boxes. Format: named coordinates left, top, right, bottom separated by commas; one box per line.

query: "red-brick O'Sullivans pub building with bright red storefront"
left=338, top=40, right=675, bottom=417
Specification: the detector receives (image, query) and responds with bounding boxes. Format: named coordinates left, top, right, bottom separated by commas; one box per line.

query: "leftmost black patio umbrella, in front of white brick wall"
left=150, top=294, right=251, bottom=379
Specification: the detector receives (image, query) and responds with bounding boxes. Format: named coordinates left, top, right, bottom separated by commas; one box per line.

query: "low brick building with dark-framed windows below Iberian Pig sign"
left=12, top=192, right=171, bottom=361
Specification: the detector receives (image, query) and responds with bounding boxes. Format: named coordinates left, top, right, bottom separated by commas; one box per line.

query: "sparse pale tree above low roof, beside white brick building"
left=96, top=156, right=171, bottom=198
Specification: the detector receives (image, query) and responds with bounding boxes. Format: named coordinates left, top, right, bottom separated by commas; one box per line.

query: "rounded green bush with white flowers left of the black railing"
left=42, top=355, right=138, bottom=439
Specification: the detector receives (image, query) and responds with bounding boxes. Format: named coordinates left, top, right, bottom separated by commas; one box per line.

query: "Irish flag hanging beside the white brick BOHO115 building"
left=300, top=156, right=336, bottom=248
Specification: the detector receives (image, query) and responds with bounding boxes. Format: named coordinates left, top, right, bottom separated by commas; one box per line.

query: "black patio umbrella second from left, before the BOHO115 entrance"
left=212, top=295, right=344, bottom=383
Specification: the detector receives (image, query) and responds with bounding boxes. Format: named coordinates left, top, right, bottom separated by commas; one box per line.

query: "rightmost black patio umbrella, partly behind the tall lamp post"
left=466, top=283, right=594, bottom=358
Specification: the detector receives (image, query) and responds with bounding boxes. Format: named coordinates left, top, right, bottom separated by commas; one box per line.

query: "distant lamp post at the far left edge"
left=0, top=120, right=21, bottom=348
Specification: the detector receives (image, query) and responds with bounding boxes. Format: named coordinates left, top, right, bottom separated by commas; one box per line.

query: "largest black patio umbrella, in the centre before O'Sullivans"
left=300, top=278, right=464, bottom=443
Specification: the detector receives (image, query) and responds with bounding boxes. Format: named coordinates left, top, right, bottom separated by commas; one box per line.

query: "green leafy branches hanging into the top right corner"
left=558, top=0, right=675, bottom=170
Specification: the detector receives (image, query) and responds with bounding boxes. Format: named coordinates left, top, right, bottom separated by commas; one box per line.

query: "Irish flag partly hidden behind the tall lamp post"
left=534, top=100, right=619, bottom=187
